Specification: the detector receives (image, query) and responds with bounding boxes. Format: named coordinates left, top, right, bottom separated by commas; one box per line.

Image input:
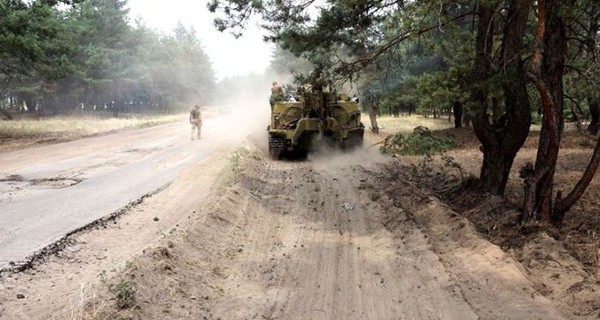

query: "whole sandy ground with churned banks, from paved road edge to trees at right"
left=0, top=118, right=600, bottom=320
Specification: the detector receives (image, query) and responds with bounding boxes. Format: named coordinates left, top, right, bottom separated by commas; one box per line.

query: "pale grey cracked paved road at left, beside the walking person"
left=0, top=121, right=214, bottom=270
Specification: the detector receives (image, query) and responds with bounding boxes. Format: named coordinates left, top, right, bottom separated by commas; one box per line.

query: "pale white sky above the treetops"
left=128, top=0, right=273, bottom=80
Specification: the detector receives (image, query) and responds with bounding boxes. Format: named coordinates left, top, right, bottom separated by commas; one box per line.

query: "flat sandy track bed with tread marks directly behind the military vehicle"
left=206, top=152, right=477, bottom=319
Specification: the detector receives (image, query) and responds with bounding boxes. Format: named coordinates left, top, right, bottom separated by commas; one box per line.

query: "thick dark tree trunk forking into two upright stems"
left=471, top=0, right=531, bottom=195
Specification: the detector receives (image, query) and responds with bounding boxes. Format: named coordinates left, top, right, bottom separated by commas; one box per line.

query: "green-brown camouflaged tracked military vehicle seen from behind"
left=267, top=91, right=365, bottom=159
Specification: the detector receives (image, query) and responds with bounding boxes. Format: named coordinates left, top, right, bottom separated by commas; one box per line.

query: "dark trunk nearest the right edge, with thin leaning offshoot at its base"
left=524, top=0, right=600, bottom=227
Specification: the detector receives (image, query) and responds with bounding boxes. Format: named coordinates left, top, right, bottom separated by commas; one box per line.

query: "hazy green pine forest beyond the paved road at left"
left=0, top=0, right=216, bottom=118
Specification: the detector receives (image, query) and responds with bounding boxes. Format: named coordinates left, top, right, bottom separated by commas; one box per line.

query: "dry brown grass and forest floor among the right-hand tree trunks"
left=366, top=121, right=600, bottom=277
